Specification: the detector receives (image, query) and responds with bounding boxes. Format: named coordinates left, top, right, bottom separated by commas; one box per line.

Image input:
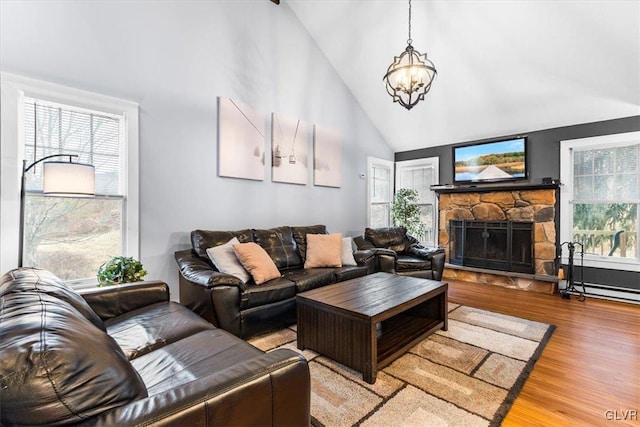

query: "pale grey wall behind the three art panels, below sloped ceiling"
left=0, top=0, right=393, bottom=299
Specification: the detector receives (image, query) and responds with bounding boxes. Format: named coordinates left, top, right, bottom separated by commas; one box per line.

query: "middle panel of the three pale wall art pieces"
left=271, top=113, right=309, bottom=185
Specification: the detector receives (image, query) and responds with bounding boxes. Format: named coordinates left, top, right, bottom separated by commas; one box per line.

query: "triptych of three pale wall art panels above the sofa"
left=218, top=97, right=342, bottom=188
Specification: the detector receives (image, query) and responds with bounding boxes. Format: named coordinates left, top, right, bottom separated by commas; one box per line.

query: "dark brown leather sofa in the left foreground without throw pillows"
left=0, top=269, right=310, bottom=426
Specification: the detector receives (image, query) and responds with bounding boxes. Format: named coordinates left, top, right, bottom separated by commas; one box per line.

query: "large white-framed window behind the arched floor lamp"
left=0, top=74, right=138, bottom=284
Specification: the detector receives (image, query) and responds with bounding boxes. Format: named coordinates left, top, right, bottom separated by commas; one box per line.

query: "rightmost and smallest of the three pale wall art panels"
left=313, top=125, right=342, bottom=188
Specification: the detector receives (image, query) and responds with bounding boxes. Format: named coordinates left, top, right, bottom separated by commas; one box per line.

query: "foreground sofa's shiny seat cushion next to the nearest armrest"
left=132, top=328, right=263, bottom=396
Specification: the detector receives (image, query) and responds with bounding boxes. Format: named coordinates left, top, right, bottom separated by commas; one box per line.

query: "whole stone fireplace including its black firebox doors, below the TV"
left=436, top=185, right=557, bottom=293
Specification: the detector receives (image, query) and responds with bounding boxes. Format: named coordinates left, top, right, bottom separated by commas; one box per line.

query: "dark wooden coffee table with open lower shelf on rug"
left=296, top=273, right=448, bottom=384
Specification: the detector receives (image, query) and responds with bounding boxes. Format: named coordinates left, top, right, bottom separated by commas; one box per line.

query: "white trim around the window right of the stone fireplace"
left=560, top=132, right=640, bottom=271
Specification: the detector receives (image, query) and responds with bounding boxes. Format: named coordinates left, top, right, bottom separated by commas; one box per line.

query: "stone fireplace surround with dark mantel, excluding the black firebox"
left=435, top=184, right=558, bottom=293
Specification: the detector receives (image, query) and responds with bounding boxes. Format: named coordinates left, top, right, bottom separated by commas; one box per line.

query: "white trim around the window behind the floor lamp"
left=0, top=72, right=140, bottom=280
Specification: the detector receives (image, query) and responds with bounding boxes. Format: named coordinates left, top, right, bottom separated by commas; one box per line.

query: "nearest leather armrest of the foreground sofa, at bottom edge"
left=87, top=349, right=311, bottom=426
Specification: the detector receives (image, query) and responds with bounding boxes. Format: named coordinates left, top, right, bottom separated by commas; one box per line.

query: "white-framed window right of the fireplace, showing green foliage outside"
left=560, top=132, right=640, bottom=270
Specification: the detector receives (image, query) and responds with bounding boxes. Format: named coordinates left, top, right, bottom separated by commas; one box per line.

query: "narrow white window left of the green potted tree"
left=367, top=157, right=393, bottom=228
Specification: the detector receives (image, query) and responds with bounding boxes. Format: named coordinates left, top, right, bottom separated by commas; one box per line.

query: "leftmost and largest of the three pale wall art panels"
left=218, top=97, right=266, bottom=181
